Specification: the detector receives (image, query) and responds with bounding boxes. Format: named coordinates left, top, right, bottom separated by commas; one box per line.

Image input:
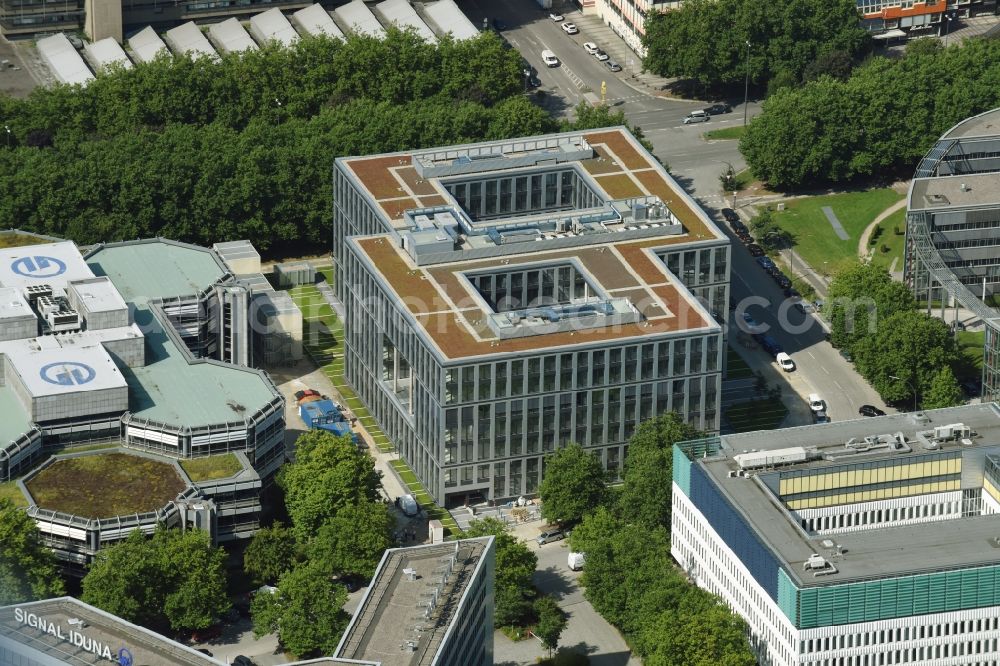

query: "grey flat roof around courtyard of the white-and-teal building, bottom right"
left=693, top=403, right=1000, bottom=587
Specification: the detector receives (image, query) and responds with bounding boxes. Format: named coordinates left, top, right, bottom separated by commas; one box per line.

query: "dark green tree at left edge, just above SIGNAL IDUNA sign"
left=0, top=499, right=65, bottom=606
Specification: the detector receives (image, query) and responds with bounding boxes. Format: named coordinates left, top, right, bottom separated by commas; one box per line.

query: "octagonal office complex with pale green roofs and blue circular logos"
left=0, top=231, right=301, bottom=573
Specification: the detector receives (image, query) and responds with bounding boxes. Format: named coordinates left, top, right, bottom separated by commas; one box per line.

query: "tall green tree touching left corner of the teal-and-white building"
left=617, top=412, right=704, bottom=530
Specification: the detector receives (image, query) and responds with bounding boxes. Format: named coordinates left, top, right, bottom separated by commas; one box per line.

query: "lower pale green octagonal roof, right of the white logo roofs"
left=121, top=305, right=277, bottom=428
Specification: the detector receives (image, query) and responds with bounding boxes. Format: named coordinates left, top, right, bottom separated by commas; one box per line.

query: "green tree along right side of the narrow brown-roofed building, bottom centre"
left=465, top=518, right=538, bottom=626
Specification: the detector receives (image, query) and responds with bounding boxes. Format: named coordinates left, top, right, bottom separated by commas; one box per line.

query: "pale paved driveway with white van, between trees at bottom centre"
left=493, top=526, right=642, bottom=666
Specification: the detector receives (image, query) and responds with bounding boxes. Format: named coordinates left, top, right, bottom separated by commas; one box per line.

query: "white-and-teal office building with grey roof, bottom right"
left=671, top=403, right=1000, bottom=666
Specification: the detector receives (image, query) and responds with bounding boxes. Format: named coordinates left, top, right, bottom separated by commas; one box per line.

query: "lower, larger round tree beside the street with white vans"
left=854, top=310, right=960, bottom=402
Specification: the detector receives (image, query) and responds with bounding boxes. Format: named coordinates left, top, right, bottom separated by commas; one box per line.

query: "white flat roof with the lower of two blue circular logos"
left=7, top=344, right=126, bottom=398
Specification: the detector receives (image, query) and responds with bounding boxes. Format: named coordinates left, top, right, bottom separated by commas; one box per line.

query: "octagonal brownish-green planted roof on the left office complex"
left=25, top=453, right=185, bottom=518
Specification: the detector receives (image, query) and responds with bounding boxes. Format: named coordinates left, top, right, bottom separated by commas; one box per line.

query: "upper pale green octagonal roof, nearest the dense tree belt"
left=86, top=240, right=226, bottom=303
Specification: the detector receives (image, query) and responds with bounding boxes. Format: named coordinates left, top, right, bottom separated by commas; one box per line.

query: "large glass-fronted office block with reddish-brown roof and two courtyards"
left=333, top=128, right=729, bottom=504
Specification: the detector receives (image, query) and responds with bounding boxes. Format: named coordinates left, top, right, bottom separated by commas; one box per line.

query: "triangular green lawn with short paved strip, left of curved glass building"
left=774, top=189, right=903, bottom=275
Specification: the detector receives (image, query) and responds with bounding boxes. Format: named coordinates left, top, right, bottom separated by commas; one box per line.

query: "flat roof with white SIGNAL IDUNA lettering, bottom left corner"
left=0, top=597, right=223, bottom=666
